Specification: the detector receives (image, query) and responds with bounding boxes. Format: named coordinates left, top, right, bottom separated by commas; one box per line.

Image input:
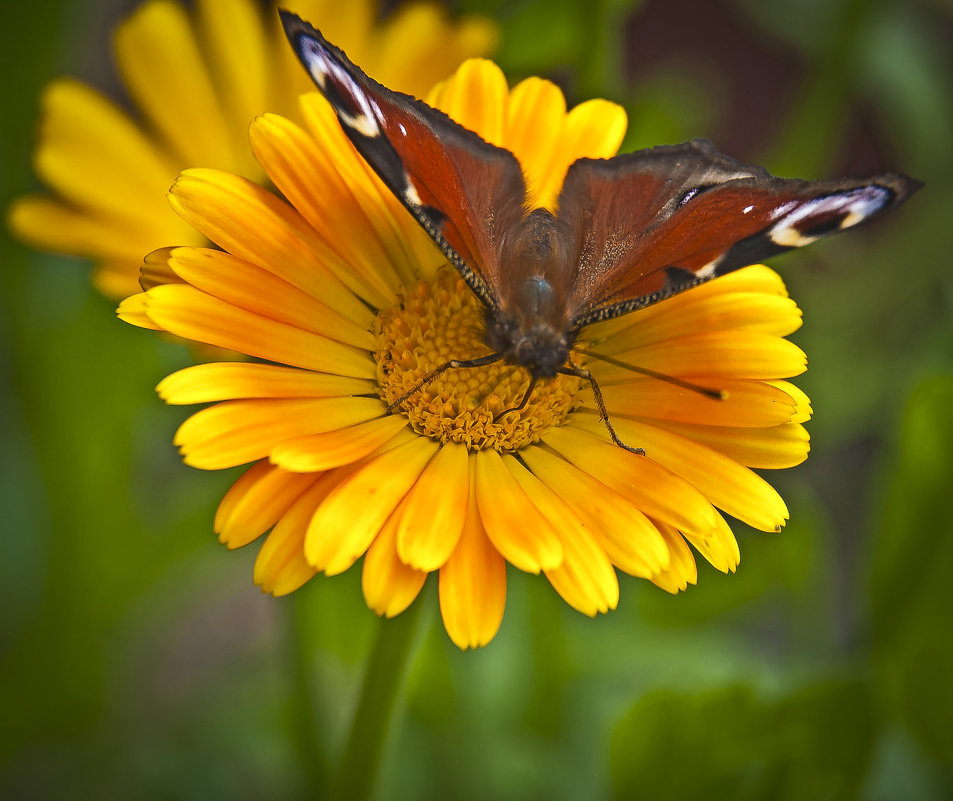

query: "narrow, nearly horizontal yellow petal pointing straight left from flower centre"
left=158, top=360, right=374, bottom=404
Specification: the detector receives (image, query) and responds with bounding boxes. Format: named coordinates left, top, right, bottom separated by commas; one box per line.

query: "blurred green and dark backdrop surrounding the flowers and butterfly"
left=0, top=0, right=953, bottom=801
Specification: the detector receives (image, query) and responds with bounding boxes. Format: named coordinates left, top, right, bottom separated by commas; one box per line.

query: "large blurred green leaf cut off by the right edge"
left=872, top=375, right=953, bottom=769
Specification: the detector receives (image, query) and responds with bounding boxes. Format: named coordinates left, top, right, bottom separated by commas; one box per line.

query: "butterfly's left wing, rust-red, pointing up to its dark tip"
left=279, top=11, right=526, bottom=308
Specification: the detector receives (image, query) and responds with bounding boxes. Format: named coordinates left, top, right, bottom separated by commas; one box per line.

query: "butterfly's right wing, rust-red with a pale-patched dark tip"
left=559, top=140, right=920, bottom=329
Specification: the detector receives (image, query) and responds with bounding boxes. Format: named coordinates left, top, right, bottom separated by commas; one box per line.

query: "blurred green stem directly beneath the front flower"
left=335, top=598, right=426, bottom=801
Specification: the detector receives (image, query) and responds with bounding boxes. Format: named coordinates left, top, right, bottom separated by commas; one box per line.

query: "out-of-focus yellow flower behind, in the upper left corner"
left=9, top=0, right=496, bottom=299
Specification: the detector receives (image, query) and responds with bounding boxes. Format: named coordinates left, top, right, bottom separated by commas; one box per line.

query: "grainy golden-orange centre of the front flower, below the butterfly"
left=376, top=269, right=580, bottom=451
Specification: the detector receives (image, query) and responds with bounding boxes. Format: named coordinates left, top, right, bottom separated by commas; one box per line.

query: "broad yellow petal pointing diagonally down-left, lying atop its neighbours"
left=305, top=436, right=438, bottom=576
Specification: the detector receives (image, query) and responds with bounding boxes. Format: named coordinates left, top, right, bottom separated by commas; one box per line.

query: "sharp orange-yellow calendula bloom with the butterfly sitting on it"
left=120, top=60, right=809, bottom=648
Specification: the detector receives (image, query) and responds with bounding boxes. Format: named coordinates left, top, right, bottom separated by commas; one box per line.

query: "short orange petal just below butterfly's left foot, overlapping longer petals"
left=268, top=414, right=407, bottom=472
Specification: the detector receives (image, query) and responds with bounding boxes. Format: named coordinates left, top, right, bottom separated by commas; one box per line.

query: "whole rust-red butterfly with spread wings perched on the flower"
left=279, top=10, right=921, bottom=453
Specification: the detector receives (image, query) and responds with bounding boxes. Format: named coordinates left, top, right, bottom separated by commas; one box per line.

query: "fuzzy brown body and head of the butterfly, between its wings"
left=486, top=209, right=574, bottom=378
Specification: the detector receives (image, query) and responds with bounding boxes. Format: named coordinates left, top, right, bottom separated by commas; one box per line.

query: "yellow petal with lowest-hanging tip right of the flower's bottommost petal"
left=503, top=455, right=619, bottom=617
